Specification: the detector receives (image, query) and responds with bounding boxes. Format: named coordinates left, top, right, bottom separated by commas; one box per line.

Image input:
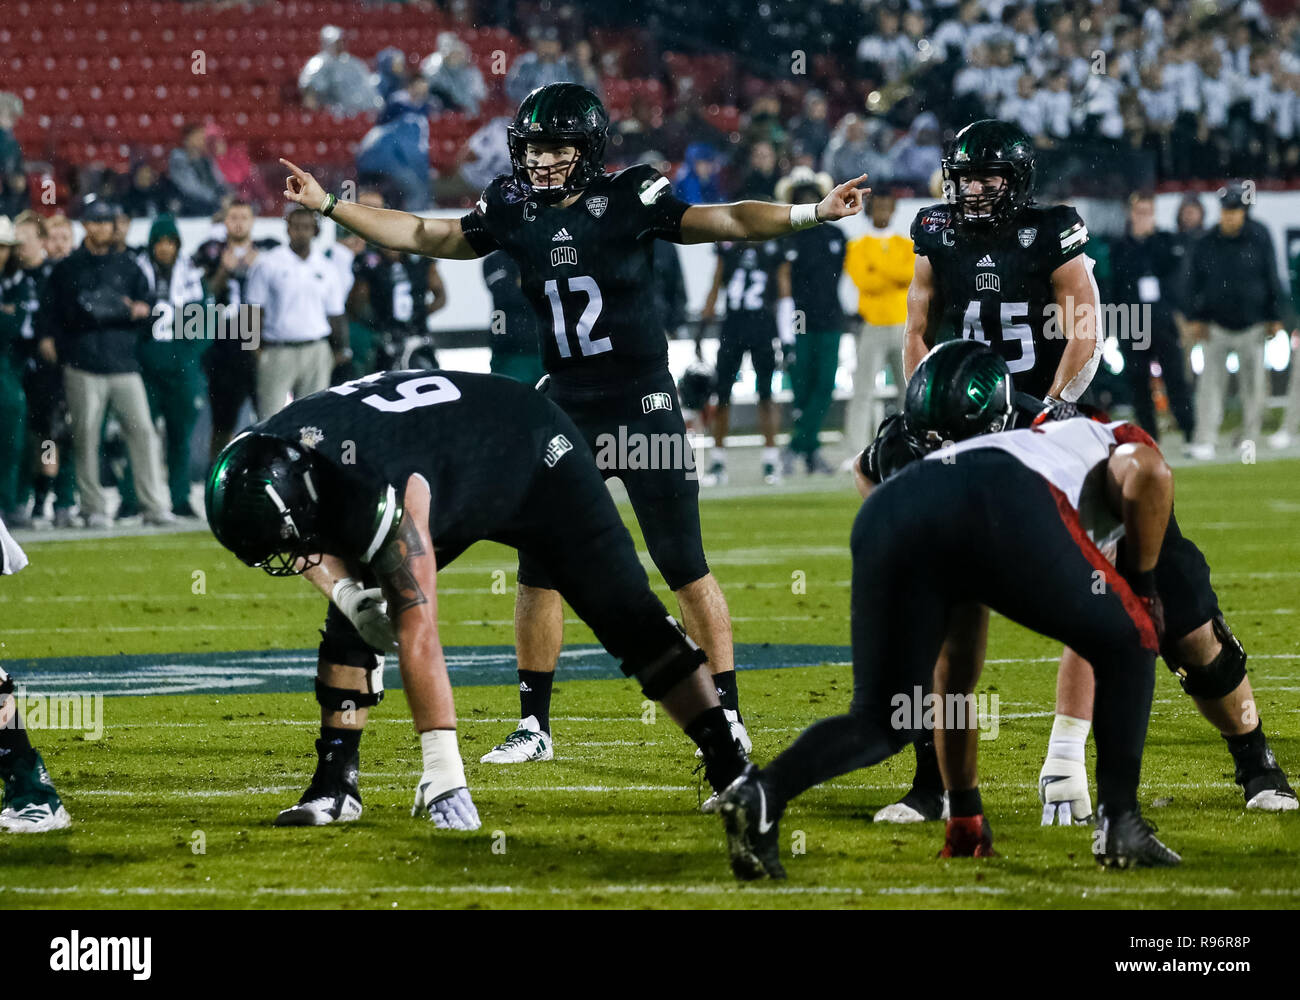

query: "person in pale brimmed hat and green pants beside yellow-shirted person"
left=776, top=168, right=845, bottom=476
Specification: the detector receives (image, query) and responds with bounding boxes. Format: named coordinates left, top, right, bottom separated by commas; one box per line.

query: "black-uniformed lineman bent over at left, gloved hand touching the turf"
left=205, top=371, right=745, bottom=830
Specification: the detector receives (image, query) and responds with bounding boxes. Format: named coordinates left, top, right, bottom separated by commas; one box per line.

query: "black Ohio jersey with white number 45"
left=911, top=204, right=1088, bottom=398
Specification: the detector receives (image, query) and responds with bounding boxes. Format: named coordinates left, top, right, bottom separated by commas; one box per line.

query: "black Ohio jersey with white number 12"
left=460, top=165, right=688, bottom=388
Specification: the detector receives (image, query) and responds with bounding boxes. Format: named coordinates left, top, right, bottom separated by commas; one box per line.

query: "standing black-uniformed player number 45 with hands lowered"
left=876, top=120, right=1101, bottom=823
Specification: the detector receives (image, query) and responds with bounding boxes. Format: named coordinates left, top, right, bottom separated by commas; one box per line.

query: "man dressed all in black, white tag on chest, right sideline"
left=1110, top=194, right=1193, bottom=443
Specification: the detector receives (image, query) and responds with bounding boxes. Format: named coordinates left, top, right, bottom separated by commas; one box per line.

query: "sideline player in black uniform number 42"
left=699, top=239, right=794, bottom=486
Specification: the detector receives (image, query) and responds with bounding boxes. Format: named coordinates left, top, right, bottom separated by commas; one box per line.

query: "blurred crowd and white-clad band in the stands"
left=0, top=0, right=1300, bottom=217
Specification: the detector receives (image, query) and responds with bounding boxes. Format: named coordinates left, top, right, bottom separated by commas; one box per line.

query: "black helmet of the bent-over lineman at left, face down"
left=203, top=432, right=321, bottom=576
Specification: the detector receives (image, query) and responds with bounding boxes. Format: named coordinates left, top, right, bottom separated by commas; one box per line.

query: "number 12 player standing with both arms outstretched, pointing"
left=282, top=83, right=867, bottom=775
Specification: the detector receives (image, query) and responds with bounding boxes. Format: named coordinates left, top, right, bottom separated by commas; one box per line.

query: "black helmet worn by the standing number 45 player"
left=943, top=118, right=1034, bottom=229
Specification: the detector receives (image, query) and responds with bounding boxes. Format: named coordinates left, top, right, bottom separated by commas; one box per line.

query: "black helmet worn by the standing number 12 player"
left=507, top=83, right=610, bottom=203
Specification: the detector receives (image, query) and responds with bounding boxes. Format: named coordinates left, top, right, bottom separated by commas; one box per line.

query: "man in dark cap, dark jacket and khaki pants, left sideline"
left=40, top=192, right=176, bottom=528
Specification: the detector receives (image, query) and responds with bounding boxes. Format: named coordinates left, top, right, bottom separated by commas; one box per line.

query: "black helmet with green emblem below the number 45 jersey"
left=904, top=341, right=1014, bottom=453
